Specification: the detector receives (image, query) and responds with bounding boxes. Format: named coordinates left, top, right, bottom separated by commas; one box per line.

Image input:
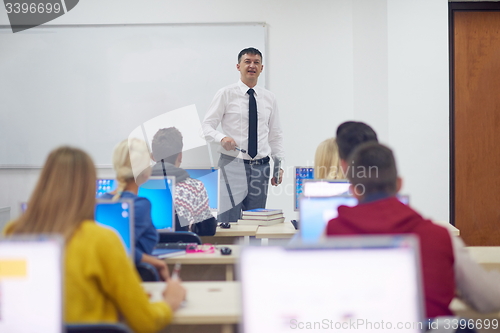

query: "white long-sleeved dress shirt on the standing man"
left=202, top=80, right=285, bottom=160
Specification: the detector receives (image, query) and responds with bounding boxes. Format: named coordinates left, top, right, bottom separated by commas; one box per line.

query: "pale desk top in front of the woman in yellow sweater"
left=142, top=281, right=241, bottom=325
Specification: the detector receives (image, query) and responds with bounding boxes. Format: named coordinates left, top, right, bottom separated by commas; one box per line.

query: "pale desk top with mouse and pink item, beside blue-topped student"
left=165, top=245, right=240, bottom=265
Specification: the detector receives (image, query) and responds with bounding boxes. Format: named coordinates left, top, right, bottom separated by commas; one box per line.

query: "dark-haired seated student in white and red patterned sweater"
left=151, top=127, right=217, bottom=236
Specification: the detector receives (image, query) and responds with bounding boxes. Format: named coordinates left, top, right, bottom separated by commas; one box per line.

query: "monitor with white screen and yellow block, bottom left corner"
left=0, top=237, right=65, bottom=333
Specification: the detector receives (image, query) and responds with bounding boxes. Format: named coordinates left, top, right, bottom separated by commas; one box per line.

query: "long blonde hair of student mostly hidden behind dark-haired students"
left=314, top=138, right=345, bottom=179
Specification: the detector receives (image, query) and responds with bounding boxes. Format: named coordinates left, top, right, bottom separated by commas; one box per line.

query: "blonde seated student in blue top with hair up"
left=100, top=139, right=168, bottom=280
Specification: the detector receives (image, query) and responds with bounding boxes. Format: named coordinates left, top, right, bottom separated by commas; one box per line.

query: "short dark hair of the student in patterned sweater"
left=151, top=127, right=186, bottom=164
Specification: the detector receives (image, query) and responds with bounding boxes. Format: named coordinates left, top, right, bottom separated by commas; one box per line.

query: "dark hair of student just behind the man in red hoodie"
left=337, top=121, right=378, bottom=161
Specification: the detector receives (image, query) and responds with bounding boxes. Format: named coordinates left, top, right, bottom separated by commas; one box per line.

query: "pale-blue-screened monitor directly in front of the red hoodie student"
left=299, top=193, right=409, bottom=243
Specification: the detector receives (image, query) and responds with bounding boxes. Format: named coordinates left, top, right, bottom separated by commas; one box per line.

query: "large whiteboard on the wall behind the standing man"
left=0, top=23, right=267, bottom=167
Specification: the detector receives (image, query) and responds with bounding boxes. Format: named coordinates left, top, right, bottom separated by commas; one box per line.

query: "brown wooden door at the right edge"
left=456, top=7, right=500, bottom=246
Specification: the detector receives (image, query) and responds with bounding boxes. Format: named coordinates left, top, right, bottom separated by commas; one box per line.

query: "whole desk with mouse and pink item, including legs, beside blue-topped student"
left=165, top=245, right=240, bottom=281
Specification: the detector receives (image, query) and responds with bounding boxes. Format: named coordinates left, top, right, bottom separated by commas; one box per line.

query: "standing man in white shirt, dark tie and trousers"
left=203, top=48, right=284, bottom=222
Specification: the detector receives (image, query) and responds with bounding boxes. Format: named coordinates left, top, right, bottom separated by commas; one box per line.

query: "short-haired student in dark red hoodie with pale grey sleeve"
left=326, top=142, right=500, bottom=318
